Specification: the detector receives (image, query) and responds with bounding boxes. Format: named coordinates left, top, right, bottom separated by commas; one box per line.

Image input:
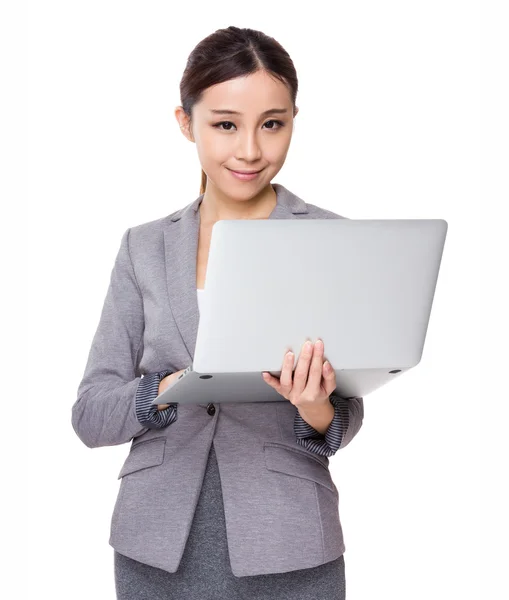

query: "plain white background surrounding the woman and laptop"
left=14, top=0, right=508, bottom=600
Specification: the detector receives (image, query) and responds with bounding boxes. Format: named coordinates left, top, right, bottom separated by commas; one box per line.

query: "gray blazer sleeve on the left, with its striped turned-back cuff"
left=71, top=228, right=176, bottom=448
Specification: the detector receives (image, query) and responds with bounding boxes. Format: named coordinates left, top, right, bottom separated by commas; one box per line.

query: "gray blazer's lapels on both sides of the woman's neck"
left=163, top=183, right=308, bottom=362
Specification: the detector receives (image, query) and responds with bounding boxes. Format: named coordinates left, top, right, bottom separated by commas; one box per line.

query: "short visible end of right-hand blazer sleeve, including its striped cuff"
left=294, top=394, right=364, bottom=456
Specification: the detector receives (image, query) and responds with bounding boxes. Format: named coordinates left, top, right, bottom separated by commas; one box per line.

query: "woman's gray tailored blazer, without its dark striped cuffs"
left=72, top=183, right=364, bottom=577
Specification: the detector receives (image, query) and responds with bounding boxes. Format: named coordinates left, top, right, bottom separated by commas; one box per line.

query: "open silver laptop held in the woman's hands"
left=152, top=219, right=448, bottom=404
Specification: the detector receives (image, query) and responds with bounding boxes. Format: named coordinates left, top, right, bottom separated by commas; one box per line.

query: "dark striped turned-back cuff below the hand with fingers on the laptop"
left=293, top=394, right=350, bottom=456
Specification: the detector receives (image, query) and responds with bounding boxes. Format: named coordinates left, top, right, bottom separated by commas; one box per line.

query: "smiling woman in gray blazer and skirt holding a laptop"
left=72, top=27, right=363, bottom=600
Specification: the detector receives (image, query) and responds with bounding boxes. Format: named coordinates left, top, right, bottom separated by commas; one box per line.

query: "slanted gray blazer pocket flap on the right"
left=263, top=442, right=335, bottom=493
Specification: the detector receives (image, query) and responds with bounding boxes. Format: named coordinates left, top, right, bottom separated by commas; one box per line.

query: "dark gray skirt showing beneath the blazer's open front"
left=114, top=444, right=346, bottom=600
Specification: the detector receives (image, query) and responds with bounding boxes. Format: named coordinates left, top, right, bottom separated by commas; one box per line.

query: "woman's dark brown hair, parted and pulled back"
left=180, top=26, right=298, bottom=195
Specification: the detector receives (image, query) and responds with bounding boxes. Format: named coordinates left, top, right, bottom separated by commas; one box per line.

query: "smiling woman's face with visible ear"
left=175, top=71, right=298, bottom=197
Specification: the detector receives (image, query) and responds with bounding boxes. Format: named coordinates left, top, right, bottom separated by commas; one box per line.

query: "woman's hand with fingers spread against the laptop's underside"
left=262, top=339, right=336, bottom=412
